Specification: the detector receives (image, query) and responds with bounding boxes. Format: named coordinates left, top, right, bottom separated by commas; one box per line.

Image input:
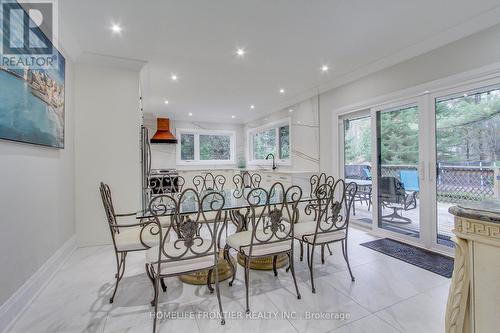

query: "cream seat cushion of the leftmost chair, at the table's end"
left=115, top=225, right=168, bottom=251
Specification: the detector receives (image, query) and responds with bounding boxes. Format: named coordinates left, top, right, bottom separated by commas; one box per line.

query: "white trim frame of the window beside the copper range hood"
left=176, top=128, right=236, bottom=165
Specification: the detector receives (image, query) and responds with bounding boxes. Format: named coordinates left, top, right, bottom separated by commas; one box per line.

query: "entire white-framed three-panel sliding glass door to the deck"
left=339, top=78, right=500, bottom=254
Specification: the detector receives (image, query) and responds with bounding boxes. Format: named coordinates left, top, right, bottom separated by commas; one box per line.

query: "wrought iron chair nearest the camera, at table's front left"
left=146, top=189, right=225, bottom=332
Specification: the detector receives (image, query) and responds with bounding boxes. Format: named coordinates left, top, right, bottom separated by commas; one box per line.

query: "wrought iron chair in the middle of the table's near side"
left=224, top=183, right=302, bottom=313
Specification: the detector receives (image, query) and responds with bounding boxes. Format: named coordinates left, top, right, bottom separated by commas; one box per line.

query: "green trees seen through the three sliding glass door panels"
left=344, top=90, right=500, bottom=165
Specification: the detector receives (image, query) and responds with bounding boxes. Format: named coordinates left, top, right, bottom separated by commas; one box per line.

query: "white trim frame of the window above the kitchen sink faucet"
left=247, top=117, right=293, bottom=166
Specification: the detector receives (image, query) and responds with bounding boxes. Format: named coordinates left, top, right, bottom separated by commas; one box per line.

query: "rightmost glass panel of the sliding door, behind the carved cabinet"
left=433, top=86, right=500, bottom=246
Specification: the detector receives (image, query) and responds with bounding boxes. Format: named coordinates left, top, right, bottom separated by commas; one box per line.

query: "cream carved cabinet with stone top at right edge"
left=445, top=200, right=500, bottom=333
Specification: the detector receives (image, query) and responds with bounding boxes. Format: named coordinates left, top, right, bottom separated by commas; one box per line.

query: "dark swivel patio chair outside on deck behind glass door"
left=379, top=177, right=418, bottom=223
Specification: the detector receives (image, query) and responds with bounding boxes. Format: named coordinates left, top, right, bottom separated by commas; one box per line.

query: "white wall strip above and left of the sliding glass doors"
left=320, top=25, right=500, bottom=176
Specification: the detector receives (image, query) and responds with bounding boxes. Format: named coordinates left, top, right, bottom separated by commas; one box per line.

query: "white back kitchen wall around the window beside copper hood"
left=144, top=114, right=245, bottom=170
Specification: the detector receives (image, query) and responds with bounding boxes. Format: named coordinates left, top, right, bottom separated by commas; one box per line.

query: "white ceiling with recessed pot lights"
left=59, top=0, right=500, bottom=123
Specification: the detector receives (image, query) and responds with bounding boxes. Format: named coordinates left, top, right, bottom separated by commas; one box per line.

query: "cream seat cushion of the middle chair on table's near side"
left=226, top=230, right=292, bottom=256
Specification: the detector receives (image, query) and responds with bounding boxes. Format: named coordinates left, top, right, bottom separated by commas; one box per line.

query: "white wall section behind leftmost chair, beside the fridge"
left=75, top=64, right=142, bottom=246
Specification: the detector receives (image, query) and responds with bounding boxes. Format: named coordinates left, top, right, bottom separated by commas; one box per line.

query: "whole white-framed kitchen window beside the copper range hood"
left=177, top=129, right=235, bottom=164
